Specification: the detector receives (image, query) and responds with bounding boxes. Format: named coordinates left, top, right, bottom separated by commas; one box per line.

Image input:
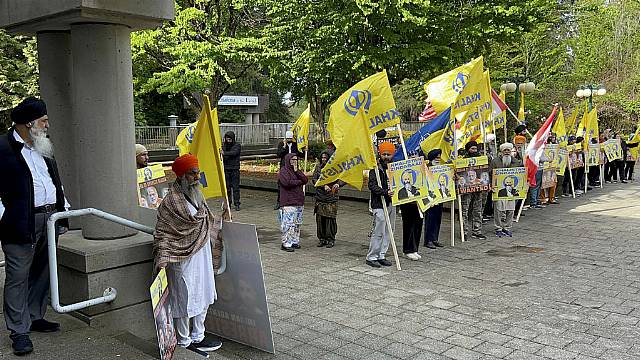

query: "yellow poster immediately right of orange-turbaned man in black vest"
left=387, top=157, right=436, bottom=206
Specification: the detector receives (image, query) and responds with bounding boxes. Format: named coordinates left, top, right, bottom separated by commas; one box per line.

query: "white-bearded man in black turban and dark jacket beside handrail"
left=0, top=97, right=68, bottom=355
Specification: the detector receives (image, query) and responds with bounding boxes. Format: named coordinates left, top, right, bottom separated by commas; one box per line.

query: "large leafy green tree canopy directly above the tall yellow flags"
left=261, top=0, right=555, bottom=140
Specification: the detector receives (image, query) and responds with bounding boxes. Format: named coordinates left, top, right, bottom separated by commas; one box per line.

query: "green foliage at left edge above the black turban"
left=0, top=30, right=39, bottom=130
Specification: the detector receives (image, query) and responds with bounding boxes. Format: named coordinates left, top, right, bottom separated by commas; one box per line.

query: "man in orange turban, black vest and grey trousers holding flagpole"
left=366, top=141, right=396, bottom=268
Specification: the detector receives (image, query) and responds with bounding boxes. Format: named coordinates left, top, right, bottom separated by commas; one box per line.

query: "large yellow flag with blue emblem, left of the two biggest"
left=327, top=70, right=400, bottom=147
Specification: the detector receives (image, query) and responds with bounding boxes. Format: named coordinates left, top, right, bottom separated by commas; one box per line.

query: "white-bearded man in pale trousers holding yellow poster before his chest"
left=490, top=143, right=522, bottom=237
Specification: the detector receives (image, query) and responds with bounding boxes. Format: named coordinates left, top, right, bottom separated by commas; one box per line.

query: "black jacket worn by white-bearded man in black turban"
left=0, top=128, right=68, bottom=244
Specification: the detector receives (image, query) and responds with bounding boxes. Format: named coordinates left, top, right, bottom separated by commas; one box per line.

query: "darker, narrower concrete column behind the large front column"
left=37, top=31, right=80, bottom=214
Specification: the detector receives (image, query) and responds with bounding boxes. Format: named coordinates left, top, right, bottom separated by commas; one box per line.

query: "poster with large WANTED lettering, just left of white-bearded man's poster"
left=454, top=156, right=491, bottom=194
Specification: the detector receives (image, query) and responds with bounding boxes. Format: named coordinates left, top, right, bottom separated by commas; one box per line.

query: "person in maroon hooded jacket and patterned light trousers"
left=278, top=153, right=308, bottom=252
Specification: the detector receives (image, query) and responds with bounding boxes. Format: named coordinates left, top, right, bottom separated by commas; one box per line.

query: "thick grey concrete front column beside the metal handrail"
left=71, top=23, right=137, bottom=239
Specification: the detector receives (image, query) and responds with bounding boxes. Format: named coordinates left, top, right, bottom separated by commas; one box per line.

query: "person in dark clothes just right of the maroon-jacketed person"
left=311, top=150, right=345, bottom=248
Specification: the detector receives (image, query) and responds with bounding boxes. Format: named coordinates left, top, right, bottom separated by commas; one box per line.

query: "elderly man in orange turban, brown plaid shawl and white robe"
left=153, top=154, right=222, bottom=355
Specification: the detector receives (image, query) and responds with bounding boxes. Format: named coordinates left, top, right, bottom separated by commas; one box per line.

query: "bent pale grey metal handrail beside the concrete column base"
left=47, top=208, right=153, bottom=313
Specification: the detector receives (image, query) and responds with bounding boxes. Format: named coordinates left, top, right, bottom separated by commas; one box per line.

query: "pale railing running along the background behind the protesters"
left=135, top=122, right=425, bottom=150
